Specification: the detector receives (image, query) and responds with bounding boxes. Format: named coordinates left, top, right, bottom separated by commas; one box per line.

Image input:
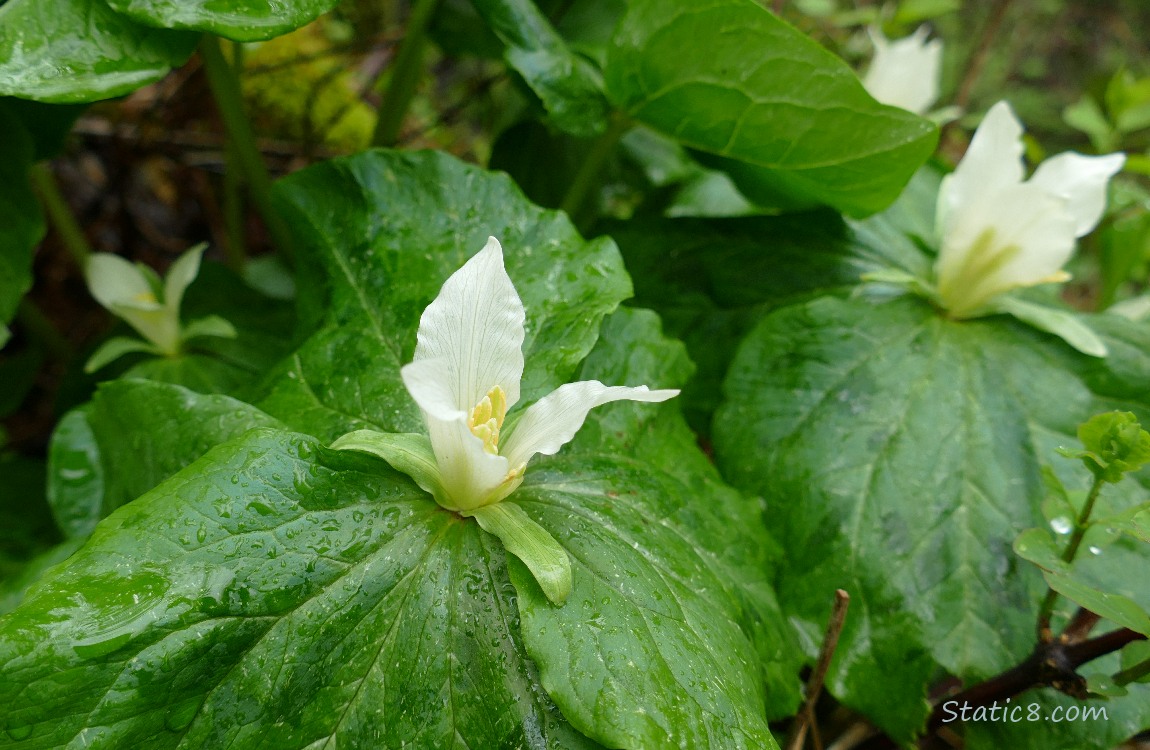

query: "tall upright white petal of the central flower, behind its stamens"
left=405, top=237, right=524, bottom=413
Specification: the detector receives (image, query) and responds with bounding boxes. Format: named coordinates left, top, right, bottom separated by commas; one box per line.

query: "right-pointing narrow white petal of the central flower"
left=501, top=381, right=679, bottom=466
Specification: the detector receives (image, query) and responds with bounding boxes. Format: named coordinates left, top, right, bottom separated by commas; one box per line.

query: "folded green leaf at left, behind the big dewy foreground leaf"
left=48, top=380, right=285, bottom=537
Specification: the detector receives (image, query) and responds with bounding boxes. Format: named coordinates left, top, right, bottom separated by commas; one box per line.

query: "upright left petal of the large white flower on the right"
left=935, top=101, right=1024, bottom=238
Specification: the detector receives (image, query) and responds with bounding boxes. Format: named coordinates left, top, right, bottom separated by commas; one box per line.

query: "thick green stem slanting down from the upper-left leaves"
left=200, top=33, right=293, bottom=259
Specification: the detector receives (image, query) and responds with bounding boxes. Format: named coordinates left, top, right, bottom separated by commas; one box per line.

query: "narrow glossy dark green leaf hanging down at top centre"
left=473, top=0, right=610, bottom=138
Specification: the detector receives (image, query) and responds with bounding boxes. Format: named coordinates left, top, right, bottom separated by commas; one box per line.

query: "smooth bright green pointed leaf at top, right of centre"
left=605, top=0, right=937, bottom=216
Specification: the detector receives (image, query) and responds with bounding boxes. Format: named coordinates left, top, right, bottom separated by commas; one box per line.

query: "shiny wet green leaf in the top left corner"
left=0, top=0, right=196, bottom=102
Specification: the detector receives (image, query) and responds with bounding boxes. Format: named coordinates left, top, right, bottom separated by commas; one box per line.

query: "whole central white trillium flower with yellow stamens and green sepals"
left=332, top=237, right=679, bottom=603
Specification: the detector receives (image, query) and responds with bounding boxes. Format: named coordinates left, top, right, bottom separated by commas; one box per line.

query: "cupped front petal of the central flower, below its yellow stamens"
left=426, top=415, right=519, bottom=511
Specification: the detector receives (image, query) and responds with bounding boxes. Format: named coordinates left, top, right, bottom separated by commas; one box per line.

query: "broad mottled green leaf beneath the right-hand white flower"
left=714, top=297, right=1150, bottom=737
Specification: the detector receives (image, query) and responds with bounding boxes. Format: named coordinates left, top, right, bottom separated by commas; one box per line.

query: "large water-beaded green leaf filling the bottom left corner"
left=0, top=430, right=596, bottom=750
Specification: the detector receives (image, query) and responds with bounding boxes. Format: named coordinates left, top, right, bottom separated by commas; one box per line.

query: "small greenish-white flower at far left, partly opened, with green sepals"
left=84, top=245, right=236, bottom=372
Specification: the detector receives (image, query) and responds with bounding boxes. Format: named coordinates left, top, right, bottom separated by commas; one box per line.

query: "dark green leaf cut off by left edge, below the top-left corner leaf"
left=0, top=100, right=45, bottom=333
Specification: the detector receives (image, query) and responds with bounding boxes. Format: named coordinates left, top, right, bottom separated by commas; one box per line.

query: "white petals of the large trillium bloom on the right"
left=935, top=101, right=1126, bottom=319
